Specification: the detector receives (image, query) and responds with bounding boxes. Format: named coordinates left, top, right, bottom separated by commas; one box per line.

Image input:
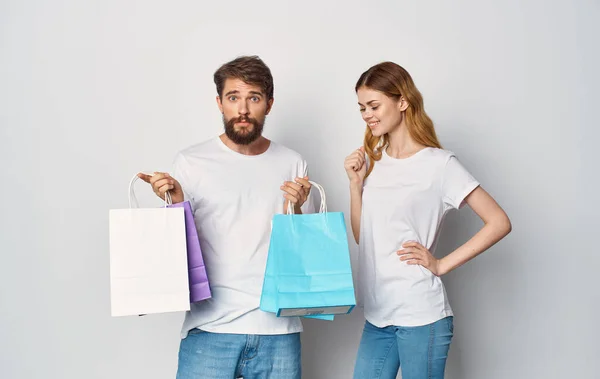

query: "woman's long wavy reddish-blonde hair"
left=355, top=62, right=442, bottom=178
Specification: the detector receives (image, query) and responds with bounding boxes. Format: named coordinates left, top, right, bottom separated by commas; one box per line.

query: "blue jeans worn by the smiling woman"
left=354, top=316, right=454, bottom=379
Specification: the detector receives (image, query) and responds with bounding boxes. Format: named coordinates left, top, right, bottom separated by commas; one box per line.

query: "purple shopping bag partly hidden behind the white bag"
left=167, top=201, right=212, bottom=303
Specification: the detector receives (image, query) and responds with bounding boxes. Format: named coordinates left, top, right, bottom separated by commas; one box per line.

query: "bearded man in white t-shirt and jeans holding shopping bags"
left=139, top=56, right=312, bottom=379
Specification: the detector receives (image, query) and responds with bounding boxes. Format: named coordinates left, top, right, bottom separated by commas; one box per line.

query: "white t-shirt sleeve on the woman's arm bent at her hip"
left=442, top=155, right=479, bottom=209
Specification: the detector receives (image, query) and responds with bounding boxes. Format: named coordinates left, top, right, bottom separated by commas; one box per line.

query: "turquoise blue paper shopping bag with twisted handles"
left=260, top=182, right=356, bottom=320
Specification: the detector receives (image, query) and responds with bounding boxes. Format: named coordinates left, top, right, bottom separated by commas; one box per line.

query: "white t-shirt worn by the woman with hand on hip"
left=358, top=148, right=479, bottom=327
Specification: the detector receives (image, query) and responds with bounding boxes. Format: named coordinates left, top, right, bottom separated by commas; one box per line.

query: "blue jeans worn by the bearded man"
left=177, top=329, right=301, bottom=379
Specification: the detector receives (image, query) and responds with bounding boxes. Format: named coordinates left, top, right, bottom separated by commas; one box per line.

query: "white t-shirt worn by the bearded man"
left=172, top=137, right=314, bottom=338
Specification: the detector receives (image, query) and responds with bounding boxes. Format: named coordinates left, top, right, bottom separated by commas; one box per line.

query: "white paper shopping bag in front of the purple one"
left=109, top=176, right=190, bottom=316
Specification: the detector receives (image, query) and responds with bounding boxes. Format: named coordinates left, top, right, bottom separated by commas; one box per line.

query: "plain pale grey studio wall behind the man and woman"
left=0, top=0, right=600, bottom=379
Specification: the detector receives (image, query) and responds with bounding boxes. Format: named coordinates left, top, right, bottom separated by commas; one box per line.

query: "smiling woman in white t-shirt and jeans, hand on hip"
left=344, top=62, right=511, bottom=379
